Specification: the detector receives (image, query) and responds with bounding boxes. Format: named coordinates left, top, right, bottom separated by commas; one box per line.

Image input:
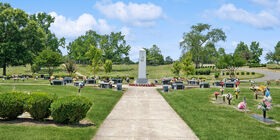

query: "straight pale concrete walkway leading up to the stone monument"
left=93, top=87, right=198, bottom=140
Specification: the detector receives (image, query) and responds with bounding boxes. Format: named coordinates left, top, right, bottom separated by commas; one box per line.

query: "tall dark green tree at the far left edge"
left=0, top=2, right=29, bottom=75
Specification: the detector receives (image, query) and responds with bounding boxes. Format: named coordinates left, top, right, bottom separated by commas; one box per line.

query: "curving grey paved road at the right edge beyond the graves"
left=239, top=68, right=280, bottom=82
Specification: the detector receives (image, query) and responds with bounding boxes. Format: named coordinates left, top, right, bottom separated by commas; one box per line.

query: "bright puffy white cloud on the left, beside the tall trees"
left=50, top=12, right=115, bottom=38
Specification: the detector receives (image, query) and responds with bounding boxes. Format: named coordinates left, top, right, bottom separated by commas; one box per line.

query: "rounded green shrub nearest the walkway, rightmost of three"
left=51, top=96, right=92, bottom=124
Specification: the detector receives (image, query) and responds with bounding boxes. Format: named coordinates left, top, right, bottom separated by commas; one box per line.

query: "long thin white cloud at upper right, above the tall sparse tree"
left=214, top=4, right=280, bottom=29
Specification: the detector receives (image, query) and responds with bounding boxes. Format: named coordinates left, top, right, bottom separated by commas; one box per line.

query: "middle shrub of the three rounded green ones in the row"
left=27, top=93, right=55, bottom=120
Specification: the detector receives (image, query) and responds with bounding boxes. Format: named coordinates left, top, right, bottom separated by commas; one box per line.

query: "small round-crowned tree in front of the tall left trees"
left=35, top=49, right=62, bottom=75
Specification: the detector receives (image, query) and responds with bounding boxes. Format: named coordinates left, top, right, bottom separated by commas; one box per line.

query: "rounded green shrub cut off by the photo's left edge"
left=0, top=91, right=28, bottom=120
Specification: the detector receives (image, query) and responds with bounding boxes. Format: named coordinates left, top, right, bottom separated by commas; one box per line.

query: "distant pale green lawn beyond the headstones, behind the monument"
left=0, top=64, right=264, bottom=82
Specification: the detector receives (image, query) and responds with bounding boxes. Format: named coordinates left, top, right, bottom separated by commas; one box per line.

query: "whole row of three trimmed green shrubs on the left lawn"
left=0, top=92, right=92, bottom=124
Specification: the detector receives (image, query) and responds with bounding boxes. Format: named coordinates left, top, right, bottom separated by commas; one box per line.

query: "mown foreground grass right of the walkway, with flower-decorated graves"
left=159, top=88, right=280, bottom=140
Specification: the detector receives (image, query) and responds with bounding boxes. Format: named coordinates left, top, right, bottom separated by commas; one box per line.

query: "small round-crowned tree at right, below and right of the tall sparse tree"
left=216, top=54, right=246, bottom=76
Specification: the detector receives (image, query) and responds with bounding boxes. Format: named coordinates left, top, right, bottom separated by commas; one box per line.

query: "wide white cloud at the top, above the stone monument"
left=95, top=1, right=164, bottom=27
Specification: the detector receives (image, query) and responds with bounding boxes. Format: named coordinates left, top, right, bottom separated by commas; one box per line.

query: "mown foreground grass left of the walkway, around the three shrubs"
left=0, top=85, right=122, bottom=140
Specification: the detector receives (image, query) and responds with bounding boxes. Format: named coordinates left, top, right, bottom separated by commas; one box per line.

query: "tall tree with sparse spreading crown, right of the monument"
left=180, top=23, right=226, bottom=67
